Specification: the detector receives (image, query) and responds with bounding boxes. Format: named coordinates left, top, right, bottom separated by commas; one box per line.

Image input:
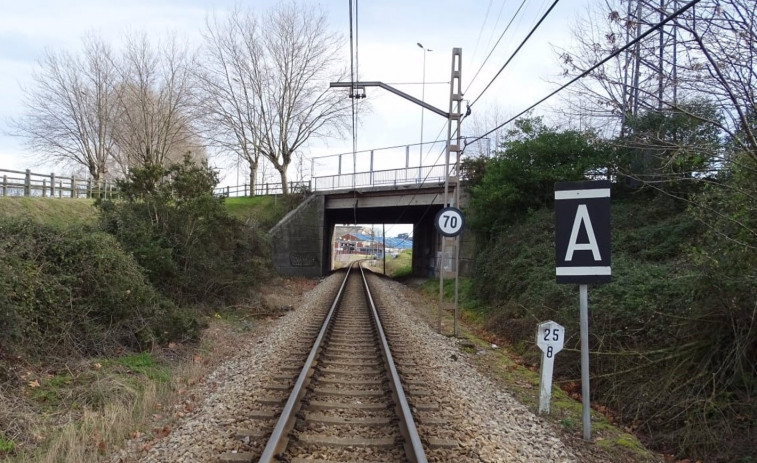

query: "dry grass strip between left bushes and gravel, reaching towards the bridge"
left=0, top=278, right=317, bottom=463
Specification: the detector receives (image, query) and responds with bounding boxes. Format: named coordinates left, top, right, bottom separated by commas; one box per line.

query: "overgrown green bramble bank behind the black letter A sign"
left=474, top=198, right=757, bottom=461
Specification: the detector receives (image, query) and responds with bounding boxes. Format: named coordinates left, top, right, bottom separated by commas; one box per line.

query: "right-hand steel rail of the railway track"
left=360, top=266, right=428, bottom=463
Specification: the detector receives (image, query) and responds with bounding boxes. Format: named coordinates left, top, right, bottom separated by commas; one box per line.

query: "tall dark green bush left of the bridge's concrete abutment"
left=98, top=158, right=268, bottom=303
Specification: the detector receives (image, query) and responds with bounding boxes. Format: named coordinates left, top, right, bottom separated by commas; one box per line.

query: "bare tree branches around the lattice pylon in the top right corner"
left=560, top=0, right=757, bottom=159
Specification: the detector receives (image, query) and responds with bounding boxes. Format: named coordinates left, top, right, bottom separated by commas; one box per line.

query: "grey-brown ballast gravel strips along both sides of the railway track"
left=109, top=274, right=578, bottom=463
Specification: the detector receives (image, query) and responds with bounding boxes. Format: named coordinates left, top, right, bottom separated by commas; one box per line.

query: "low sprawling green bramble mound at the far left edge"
left=0, top=219, right=197, bottom=379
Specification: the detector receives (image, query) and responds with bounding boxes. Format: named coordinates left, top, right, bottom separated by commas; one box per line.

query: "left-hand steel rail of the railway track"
left=258, top=266, right=352, bottom=463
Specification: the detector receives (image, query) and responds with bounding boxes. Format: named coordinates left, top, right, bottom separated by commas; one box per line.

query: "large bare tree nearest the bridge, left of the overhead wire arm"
left=200, top=2, right=349, bottom=194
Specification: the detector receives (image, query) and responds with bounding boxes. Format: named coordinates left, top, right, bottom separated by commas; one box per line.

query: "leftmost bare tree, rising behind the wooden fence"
left=11, top=36, right=118, bottom=181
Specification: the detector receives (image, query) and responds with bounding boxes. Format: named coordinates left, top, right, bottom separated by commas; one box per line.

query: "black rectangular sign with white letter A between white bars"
left=555, top=180, right=611, bottom=284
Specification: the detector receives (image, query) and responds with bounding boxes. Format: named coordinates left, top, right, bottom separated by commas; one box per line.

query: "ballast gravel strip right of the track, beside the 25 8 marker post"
left=374, top=279, right=578, bottom=463
